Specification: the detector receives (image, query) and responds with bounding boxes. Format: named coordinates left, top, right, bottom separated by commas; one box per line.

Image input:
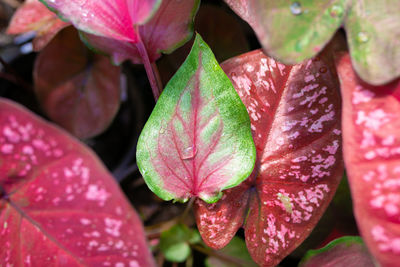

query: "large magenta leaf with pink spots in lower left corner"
left=0, top=99, right=154, bottom=266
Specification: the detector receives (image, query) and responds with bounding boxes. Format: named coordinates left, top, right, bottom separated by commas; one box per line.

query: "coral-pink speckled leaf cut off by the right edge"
left=338, top=55, right=400, bottom=267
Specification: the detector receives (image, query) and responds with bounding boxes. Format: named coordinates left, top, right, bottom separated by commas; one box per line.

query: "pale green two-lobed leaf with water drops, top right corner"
left=225, top=0, right=400, bottom=84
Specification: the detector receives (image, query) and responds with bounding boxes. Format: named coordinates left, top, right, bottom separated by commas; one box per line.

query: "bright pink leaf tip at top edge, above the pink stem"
left=40, top=0, right=161, bottom=43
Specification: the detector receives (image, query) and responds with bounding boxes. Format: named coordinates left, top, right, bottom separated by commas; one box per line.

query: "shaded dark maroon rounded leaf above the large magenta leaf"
left=33, top=27, right=121, bottom=138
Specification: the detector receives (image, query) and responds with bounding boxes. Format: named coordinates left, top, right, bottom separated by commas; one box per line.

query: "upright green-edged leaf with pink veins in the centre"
left=137, top=35, right=255, bottom=202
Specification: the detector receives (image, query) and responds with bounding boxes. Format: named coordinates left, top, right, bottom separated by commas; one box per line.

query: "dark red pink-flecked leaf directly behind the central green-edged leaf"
left=195, top=50, right=343, bottom=266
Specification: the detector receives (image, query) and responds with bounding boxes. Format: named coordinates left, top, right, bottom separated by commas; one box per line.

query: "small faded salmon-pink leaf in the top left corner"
left=7, top=0, right=69, bottom=51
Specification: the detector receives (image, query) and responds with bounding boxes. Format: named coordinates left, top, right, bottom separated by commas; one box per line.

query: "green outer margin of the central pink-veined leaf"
left=136, top=33, right=256, bottom=203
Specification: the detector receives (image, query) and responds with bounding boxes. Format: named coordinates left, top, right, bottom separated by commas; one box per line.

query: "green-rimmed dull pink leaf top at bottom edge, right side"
left=299, top=236, right=375, bottom=267
